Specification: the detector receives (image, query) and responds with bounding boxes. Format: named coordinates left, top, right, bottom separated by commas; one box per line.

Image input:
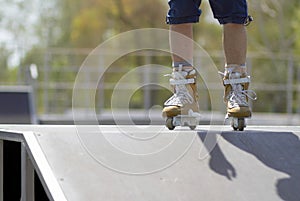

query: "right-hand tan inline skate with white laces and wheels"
left=223, top=65, right=256, bottom=131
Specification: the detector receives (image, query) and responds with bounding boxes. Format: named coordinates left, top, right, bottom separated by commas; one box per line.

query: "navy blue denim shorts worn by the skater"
left=166, top=0, right=248, bottom=24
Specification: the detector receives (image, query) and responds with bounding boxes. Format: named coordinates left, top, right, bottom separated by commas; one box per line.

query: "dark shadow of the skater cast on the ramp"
left=198, top=130, right=300, bottom=201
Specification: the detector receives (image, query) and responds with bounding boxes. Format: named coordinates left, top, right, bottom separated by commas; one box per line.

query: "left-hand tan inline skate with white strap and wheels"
left=162, top=65, right=200, bottom=130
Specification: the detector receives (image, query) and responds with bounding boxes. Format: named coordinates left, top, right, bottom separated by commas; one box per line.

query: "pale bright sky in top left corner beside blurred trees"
left=0, top=0, right=39, bottom=67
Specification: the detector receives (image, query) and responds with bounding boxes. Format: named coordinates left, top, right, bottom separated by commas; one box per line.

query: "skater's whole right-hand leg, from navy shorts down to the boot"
left=209, top=0, right=255, bottom=118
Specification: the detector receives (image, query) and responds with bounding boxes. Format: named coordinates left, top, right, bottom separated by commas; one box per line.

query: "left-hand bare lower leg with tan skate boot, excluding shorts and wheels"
left=163, top=23, right=199, bottom=117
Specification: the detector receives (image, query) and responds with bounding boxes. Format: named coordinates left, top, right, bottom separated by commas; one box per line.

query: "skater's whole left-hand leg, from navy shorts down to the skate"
left=162, top=0, right=201, bottom=129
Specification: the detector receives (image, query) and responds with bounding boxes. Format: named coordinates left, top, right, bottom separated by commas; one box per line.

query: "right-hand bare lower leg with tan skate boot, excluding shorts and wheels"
left=223, top=23, right=251, bottom=117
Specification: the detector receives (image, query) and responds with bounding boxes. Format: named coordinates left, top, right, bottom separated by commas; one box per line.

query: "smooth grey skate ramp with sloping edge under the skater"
left=0, top=125, right=300, bottom=201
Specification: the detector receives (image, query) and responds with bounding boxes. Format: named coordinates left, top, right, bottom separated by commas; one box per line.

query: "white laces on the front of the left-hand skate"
left=165, top=71, right=194, bottom=106
